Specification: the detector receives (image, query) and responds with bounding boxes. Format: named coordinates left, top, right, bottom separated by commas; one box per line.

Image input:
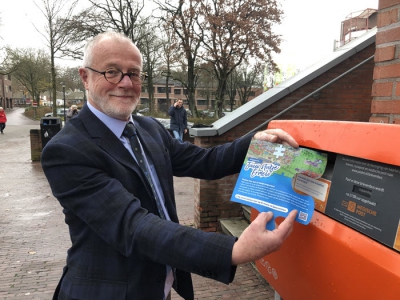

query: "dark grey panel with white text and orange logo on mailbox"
left=325, top=155, right=400, bottom=251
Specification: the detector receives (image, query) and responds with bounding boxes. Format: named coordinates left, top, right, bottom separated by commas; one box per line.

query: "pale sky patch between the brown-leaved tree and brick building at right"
left=274, top=0, right=378, bottom=70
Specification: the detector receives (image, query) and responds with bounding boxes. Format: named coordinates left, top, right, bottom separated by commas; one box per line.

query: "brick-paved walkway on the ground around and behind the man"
left=0, top=108, right=274, bottom=300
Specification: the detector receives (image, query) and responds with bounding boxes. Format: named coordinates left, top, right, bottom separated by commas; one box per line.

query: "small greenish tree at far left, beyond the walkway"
left=6, top=48, right=51, bottom=103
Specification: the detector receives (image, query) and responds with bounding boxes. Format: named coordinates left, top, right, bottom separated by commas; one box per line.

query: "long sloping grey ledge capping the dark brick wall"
left=189, top=27, right=377, bottom=137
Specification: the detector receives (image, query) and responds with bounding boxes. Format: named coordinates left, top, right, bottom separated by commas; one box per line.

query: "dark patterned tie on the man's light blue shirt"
left=122, top=123, right=165, bottom=219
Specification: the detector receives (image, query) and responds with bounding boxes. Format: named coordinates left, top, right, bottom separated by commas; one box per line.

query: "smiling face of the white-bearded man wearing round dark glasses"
left=79, top=39, right=142, bottom=121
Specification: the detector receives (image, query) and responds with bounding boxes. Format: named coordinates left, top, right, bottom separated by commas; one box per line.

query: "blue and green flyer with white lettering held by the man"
left=231, top=139, right=327, bottom=230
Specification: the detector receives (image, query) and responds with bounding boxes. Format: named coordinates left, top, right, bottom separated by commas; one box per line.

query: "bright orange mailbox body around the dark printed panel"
left=251, top=121, right=400, bottom=300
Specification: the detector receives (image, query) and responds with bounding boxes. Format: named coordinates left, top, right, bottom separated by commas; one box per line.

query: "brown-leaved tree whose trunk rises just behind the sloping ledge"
left=193, top=0, right=282, bottom=116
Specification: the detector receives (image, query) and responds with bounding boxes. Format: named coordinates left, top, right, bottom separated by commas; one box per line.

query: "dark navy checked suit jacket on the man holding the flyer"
left=41, top=105, right=251, bottom=300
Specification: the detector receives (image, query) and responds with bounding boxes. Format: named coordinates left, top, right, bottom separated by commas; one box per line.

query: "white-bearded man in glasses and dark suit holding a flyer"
left=41, top=33, right=298, bottom=300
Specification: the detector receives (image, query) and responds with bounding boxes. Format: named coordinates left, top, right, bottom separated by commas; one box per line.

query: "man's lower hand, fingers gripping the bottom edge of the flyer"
left=232, top=210, right=297, bottom=266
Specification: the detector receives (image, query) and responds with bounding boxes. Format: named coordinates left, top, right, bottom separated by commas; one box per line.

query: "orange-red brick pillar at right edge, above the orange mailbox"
left=369, top=0, right=400, bottom=124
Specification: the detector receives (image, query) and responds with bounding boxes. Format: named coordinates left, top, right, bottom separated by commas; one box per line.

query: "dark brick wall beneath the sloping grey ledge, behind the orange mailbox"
left=194, top=45, right=375, bottom=231
